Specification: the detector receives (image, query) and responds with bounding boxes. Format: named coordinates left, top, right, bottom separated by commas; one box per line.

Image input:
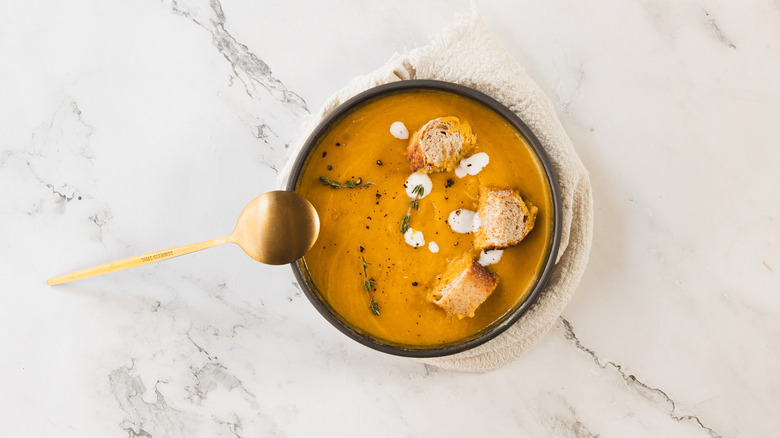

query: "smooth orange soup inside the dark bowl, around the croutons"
left=297, top=91, right=552, bottom=347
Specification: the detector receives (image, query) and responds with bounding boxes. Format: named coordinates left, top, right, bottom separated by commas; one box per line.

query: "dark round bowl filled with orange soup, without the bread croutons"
left=286, top=80, right=561, bottom=357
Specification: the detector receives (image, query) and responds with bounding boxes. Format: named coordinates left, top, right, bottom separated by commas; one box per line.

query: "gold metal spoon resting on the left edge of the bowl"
left=46, top=191, right=320, bottom=285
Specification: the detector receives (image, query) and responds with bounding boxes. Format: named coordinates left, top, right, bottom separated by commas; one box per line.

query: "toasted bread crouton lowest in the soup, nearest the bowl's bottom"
left=429, top=253, right=498, bottom=319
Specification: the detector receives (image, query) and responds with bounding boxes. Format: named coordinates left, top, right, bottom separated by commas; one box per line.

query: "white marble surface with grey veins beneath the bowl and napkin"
left=0, top=0, right=780, bottom=438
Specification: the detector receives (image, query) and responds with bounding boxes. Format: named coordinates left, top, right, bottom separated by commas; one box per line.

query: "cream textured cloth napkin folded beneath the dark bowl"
left=281, top=14, right=593, bottom=372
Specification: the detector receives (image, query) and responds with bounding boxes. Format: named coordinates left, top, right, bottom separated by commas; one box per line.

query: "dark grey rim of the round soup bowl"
left=285, top=79, right=562, bottom=358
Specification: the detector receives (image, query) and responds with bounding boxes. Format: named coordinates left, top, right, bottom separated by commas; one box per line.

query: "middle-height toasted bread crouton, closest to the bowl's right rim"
left=474, top=187, right=539, bottom=251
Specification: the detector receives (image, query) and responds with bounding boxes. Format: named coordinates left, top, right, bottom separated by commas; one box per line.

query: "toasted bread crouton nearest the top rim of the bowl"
left=406, top=116, right=477, bottom=173
